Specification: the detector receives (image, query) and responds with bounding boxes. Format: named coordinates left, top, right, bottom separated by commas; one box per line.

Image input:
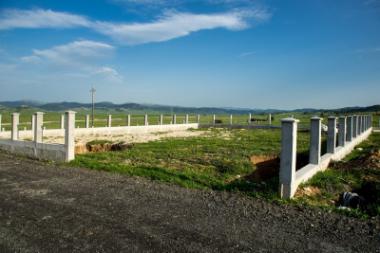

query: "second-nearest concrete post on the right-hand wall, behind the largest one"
left=309, top=117, right=322, bottom=164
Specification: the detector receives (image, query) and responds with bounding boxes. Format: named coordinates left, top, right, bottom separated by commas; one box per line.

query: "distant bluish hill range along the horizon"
left=0, top=100, right=380, bottom=114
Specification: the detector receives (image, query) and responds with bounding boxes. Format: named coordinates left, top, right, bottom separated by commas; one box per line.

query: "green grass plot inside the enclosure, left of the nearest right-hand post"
left=72, top=129, right=308, bottom=198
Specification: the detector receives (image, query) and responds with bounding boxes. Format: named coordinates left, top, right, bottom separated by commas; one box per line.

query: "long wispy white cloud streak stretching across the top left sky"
left=0, top=9, right=271, bottom=45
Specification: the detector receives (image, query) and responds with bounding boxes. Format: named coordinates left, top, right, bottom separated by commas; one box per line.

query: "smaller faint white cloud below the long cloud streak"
left=21, top=40, right=114, bottom=65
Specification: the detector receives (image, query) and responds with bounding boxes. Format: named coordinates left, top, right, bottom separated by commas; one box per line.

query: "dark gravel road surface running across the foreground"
left=0, top=153, right=380, bottom=252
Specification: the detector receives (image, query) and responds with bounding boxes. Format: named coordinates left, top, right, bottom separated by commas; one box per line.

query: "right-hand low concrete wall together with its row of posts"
left=279, top=115, right=372, bottom=198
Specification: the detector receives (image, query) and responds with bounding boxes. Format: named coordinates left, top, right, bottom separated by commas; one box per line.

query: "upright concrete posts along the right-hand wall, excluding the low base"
left=279, top=115, right=372, bottom=198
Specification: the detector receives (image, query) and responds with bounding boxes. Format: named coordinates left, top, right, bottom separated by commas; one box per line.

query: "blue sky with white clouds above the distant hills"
left=0, top=0, right=380, bottom=109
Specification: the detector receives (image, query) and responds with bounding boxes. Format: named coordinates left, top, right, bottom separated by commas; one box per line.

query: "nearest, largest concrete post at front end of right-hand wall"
left=279, top=118, right=299, bottom=198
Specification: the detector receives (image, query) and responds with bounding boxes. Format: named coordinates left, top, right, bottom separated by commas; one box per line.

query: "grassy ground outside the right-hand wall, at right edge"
left=295, top=133, right=380, bottom=217
